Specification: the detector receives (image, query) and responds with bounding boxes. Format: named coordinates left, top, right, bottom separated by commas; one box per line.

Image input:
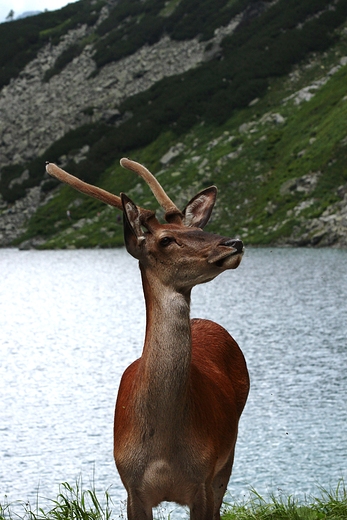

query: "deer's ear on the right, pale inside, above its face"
left=183, top=186, right=217, bottom=228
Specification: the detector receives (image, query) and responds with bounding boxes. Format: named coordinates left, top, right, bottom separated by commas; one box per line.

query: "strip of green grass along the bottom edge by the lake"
left=0, top=480, right=347, bottom=520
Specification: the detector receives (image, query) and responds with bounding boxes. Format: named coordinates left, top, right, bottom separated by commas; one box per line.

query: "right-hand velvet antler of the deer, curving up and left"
left=120, top=157, right=183, bottom=222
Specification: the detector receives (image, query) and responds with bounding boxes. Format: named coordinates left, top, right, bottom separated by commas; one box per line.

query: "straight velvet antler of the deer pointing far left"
left=46, top=162, right=123, bottom=211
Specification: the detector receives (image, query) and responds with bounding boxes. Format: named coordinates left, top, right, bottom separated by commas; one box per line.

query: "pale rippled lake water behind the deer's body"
left=0, top=249, right=347, bottom=518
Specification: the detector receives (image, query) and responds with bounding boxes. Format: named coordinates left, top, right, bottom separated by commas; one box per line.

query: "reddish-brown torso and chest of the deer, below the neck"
left=114, top=310, right=248, bottom=520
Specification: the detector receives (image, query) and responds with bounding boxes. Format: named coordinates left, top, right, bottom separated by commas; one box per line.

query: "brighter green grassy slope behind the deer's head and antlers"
left=18, top=29, right=347, bottom=248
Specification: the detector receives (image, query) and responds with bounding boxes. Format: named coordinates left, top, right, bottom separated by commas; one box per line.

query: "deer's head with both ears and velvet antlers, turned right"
left=46, top=159, right=243, bottom=290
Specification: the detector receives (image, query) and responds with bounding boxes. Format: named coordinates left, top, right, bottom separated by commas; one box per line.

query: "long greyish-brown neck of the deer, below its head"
left=139, top=268, right=192, bottom=419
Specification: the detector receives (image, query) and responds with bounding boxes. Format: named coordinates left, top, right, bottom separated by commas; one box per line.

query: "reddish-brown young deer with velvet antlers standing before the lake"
left=46, top=158, right=249, bottom=520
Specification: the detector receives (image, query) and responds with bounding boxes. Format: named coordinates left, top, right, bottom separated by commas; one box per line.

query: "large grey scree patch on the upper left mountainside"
left=0, top=6, right=246, bottom=246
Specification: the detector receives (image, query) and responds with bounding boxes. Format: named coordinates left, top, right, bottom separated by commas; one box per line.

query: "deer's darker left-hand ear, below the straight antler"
left=121, top=193, right=145, bottom=259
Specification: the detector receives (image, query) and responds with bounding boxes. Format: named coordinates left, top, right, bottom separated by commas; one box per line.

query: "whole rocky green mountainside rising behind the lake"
left=0, top=0, right=347, bottom=248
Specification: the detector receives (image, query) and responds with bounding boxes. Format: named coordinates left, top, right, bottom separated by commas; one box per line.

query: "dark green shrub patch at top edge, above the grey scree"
left=94, top=0, right=253, bottom=68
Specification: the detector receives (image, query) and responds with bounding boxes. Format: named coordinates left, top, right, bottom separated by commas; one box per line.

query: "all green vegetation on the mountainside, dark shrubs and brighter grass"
left=0, top=0, right=347, bottom=247
